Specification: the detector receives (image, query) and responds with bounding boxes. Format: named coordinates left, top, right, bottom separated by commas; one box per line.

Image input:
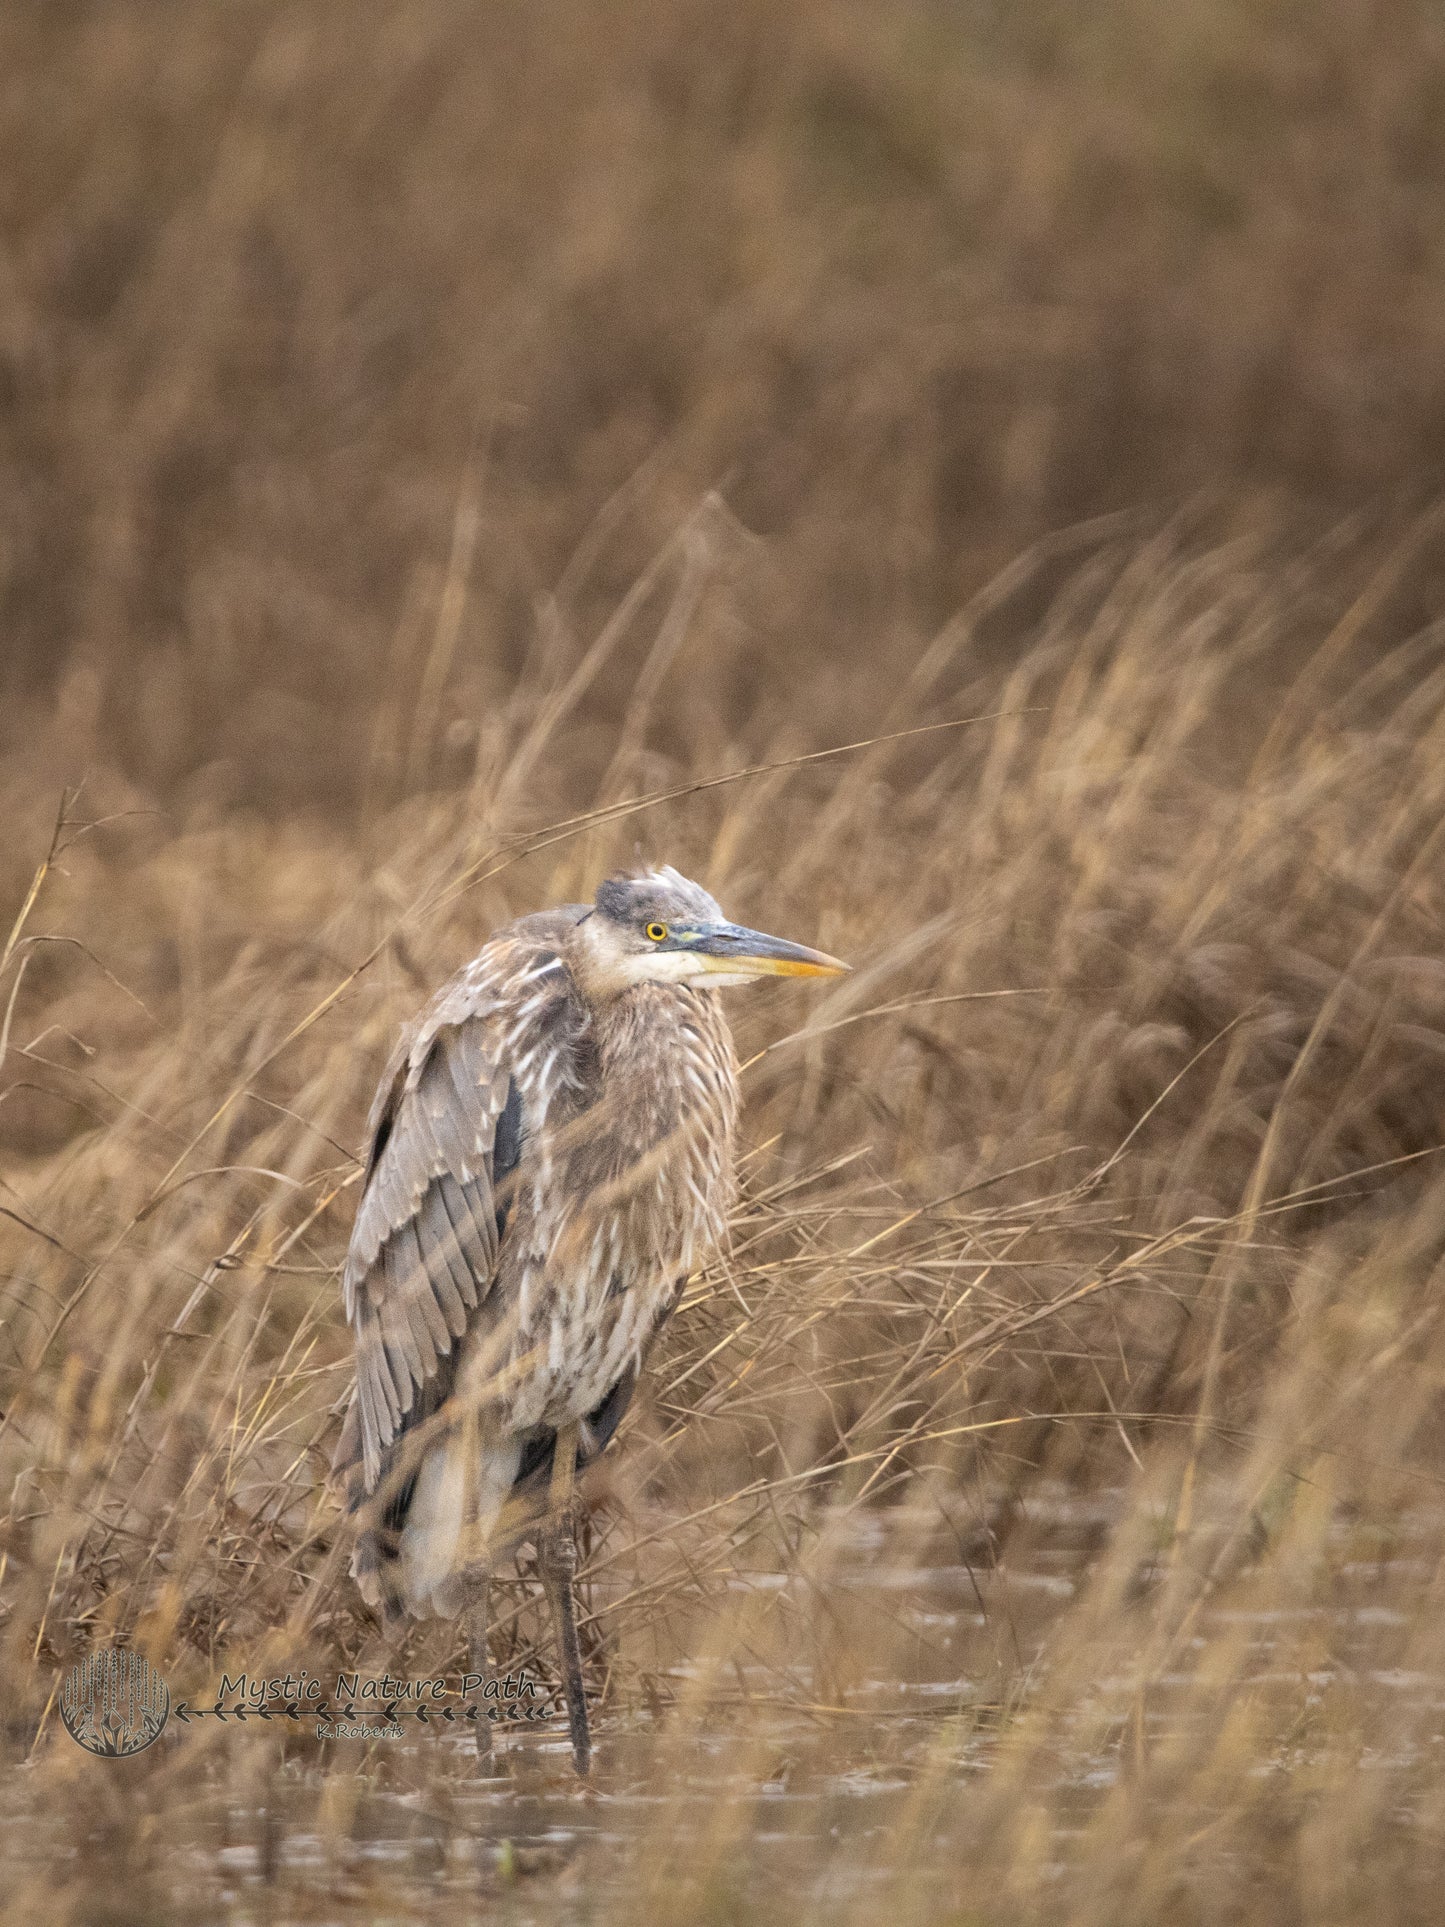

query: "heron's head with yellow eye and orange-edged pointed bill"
left=576, top=867, right=848, bottom=996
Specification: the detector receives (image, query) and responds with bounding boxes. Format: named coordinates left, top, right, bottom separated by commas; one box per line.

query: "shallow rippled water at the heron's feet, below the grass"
left=11, top=1493, right=1445, bottom=1921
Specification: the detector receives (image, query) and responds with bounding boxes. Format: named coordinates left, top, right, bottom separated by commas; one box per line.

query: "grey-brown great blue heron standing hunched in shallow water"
left=337, top=869, right=848, bottom=1773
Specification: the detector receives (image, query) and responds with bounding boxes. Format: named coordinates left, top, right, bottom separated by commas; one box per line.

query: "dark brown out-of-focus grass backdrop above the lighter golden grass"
left=0, top=0, right=1445, bottom=809
